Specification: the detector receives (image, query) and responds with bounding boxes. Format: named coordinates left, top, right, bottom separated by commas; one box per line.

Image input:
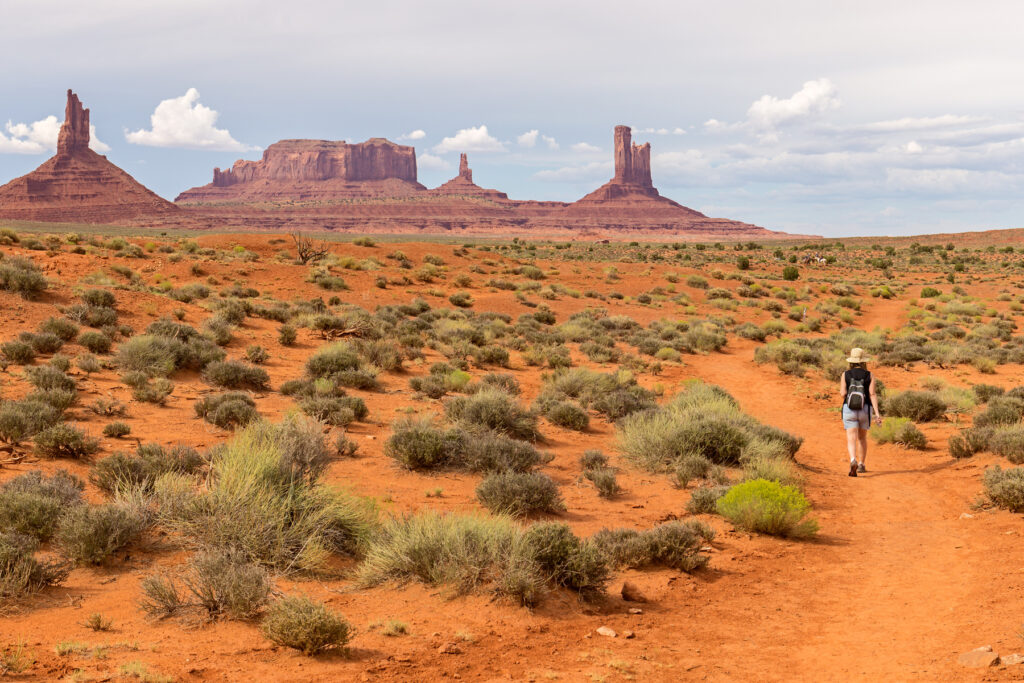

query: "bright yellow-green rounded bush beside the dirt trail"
left=717, top=479, right=818, bottom=539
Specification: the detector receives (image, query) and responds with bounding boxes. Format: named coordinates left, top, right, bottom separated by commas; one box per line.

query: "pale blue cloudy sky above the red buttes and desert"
left=0, top=0, right=1024, bottom=236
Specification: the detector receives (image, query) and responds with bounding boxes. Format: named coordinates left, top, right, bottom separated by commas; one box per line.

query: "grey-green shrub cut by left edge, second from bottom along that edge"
left=0, top=470, right=84, bottom=541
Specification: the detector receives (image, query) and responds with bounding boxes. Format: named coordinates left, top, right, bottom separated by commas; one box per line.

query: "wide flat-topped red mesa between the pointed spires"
left=175, top=137, right=426, bottom=204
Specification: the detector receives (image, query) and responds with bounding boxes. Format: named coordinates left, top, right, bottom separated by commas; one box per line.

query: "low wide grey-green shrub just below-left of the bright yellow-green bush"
left=591, top=520, right=715, bottom=571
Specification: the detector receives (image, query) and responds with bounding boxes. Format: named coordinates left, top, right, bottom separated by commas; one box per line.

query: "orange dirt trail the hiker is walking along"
left=679, top=344, right=1021, bottom=680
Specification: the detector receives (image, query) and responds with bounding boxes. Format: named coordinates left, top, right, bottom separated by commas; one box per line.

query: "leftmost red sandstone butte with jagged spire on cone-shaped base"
left=0, top=90, right=181, bottom=223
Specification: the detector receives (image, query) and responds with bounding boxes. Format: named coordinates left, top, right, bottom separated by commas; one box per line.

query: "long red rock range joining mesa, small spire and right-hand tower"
left=176, top=126, right=793, bottom=240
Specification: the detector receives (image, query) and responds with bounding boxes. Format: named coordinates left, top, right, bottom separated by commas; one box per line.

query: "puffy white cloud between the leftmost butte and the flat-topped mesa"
left=125, top=88, right=252, bottom=152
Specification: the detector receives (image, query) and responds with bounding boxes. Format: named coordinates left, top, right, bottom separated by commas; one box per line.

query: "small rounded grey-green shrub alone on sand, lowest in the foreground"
left=261, top=596, right=351, bottom=656
